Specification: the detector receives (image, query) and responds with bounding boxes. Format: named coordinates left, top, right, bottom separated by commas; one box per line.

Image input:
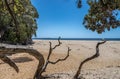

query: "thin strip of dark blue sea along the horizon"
left=32, top=38, right=120, bottom=41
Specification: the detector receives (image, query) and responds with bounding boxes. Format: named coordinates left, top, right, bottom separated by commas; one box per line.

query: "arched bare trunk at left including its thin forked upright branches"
left=0, top=38, right=71, bottom=79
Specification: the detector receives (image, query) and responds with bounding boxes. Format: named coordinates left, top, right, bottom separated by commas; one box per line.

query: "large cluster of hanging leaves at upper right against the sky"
left=78, top=0, right=120, bottom=33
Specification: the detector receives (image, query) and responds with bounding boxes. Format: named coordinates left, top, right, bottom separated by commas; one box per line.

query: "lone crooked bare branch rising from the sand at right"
left=74, top=41, right=106, bottom=79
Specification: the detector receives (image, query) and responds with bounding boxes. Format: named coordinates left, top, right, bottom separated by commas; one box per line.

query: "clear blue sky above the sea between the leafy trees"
left=31, top=0, right=120, bottom=38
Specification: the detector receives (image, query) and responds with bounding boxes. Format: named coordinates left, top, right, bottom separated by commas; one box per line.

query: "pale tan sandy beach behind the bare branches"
left=0, top=40, right=120, bottom=79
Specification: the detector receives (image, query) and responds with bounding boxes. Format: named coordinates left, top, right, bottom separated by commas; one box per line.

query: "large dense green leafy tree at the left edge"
left=0, top=0, right=39, bottom=44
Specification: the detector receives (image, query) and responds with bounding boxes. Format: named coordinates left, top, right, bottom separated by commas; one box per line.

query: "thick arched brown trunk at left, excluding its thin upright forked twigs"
left=0, top=47, right=45, bottom=79
